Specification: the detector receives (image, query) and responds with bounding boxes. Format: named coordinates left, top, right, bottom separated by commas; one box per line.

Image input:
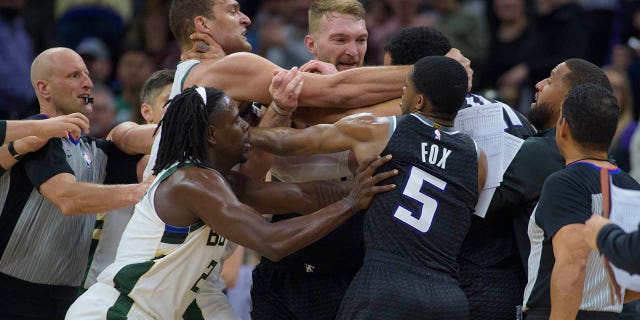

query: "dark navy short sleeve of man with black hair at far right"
left=535, top=171, right=591, bottom=239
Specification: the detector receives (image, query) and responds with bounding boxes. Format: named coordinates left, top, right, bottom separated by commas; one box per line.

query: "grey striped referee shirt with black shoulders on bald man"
left=0, top=131, right=140, bottom=286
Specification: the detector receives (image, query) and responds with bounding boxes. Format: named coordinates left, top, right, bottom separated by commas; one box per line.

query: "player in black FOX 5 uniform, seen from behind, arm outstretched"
left=250, top=56, right=486, bottom=319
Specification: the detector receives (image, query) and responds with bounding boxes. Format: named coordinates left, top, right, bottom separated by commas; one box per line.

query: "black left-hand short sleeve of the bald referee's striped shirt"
left=22, top=138, right=75, bottom=190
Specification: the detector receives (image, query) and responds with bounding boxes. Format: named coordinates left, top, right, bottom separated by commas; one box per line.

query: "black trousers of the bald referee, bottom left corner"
left=0, top=273, right=79, bottom=320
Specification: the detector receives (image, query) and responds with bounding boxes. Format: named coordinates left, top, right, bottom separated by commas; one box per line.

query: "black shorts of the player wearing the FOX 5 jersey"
left=336, top=251, right=469, bottom=320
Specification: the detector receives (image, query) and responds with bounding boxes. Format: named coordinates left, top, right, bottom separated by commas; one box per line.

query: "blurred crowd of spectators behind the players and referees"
left=0, top=0, right=640, bottom=142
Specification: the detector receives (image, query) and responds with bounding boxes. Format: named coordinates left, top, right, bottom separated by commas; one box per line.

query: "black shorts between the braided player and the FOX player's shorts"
left=251, top=259, right=355, bottom=320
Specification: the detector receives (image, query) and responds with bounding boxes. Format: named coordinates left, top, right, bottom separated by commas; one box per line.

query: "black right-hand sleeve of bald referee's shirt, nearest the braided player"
left=96, top=139, right=144, bottom=184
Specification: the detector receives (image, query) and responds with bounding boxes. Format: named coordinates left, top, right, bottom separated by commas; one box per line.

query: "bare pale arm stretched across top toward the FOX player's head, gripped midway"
left=184, top=52, right=410, bottom=108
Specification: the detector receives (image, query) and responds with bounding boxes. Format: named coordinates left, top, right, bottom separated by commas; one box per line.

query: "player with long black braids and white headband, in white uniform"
left=67, top=87, right=395, bottom=319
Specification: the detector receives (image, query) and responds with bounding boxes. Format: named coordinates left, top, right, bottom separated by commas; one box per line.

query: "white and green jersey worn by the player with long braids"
left=66, top=165, right=237, bottom=319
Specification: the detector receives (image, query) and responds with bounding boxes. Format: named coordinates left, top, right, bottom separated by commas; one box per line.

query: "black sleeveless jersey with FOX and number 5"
left=364, top=113, right=478, bottom=277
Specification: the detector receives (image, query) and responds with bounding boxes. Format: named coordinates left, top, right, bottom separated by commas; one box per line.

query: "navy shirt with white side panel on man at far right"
left=523, top=162, right=640, bottom=312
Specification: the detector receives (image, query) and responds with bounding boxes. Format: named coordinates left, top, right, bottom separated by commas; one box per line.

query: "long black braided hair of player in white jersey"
left=153, top=86, right=224, bottom=175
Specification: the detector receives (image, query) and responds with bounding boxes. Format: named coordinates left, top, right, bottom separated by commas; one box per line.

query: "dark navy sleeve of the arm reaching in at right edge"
left=596, top=224, right=640, bottom=274
